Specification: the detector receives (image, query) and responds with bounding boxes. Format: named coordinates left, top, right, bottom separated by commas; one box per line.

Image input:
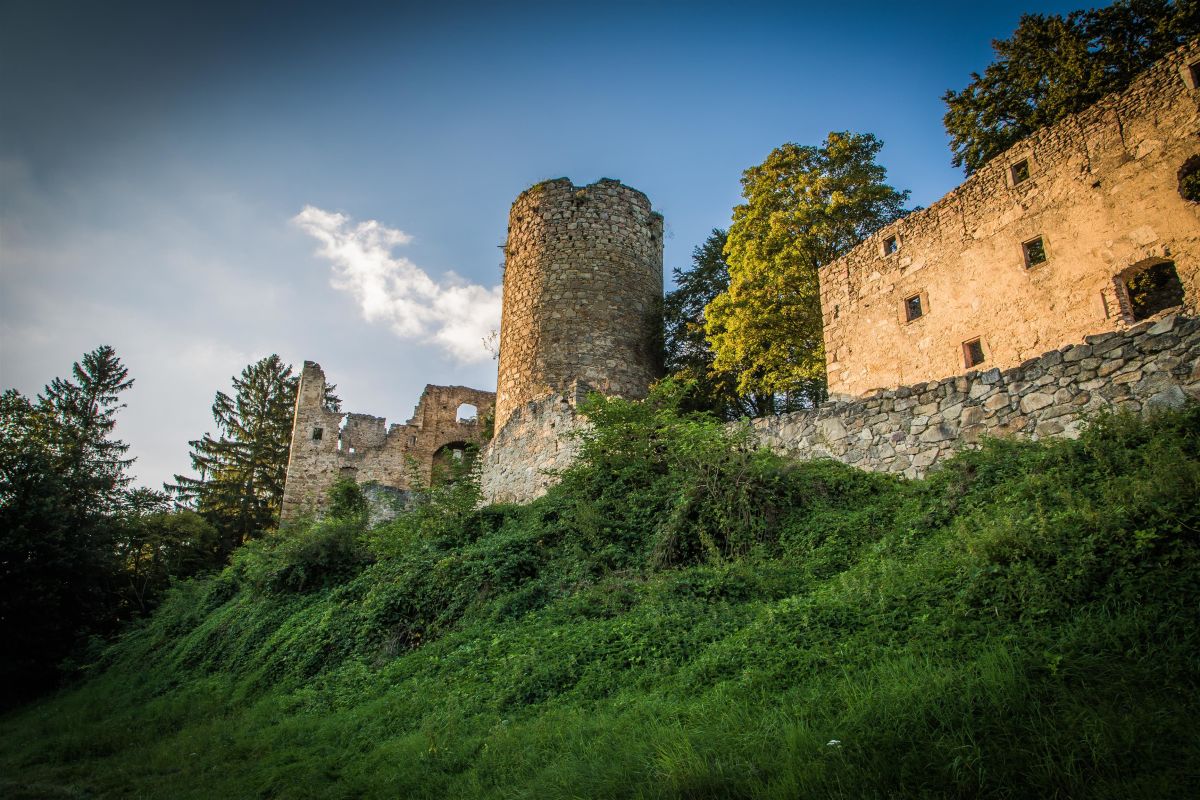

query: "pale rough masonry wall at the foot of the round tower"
left=480, top=381, right=589, bottom=503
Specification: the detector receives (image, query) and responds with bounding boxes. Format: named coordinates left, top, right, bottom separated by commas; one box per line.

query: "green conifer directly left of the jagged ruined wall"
left=169, top=355, right=340, bottom=554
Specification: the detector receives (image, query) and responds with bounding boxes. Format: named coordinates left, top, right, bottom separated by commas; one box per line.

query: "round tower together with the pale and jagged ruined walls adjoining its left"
left=282, top=179, right=662, bottom=519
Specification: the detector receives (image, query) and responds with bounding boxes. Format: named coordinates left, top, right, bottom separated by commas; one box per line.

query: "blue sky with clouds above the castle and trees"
left=0, top=0, right=1075, bottom=486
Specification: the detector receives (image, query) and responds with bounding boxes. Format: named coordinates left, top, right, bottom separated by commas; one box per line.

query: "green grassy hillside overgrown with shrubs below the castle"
left=0, top=391, right=1200, bottom=798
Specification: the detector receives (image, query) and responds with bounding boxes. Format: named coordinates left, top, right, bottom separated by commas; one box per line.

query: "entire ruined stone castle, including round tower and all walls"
left=283, top=42, right=1200, bottom=518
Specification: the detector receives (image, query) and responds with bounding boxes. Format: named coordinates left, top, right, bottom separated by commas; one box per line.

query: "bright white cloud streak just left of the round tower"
left=292, top=205, right=500, bottom=362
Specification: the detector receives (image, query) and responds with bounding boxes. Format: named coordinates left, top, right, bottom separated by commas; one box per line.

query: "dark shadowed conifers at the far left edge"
left=0, top=345, right=133, bottom=702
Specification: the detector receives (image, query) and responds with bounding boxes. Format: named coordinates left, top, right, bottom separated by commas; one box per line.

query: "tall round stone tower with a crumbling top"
left=496, top=178, right=662, bottom=431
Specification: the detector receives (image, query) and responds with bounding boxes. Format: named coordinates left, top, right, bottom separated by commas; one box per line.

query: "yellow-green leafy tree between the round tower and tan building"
left=704, top=132, right=908, bottom=407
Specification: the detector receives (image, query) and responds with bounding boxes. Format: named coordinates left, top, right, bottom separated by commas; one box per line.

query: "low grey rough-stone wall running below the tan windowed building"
left=751, top=314, right=1200, bottom=477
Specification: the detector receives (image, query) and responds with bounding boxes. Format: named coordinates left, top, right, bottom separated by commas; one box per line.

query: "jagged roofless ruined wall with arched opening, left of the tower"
left=281, top=361, right=496, bottom=521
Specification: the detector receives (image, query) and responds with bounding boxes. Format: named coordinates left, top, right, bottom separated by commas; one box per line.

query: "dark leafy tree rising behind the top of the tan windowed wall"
left=942, top=0, right=1200, bottom=174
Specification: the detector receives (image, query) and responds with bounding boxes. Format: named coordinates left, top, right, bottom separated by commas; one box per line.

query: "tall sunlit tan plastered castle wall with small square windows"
left=820, top=42, right=1200, bottom=395
